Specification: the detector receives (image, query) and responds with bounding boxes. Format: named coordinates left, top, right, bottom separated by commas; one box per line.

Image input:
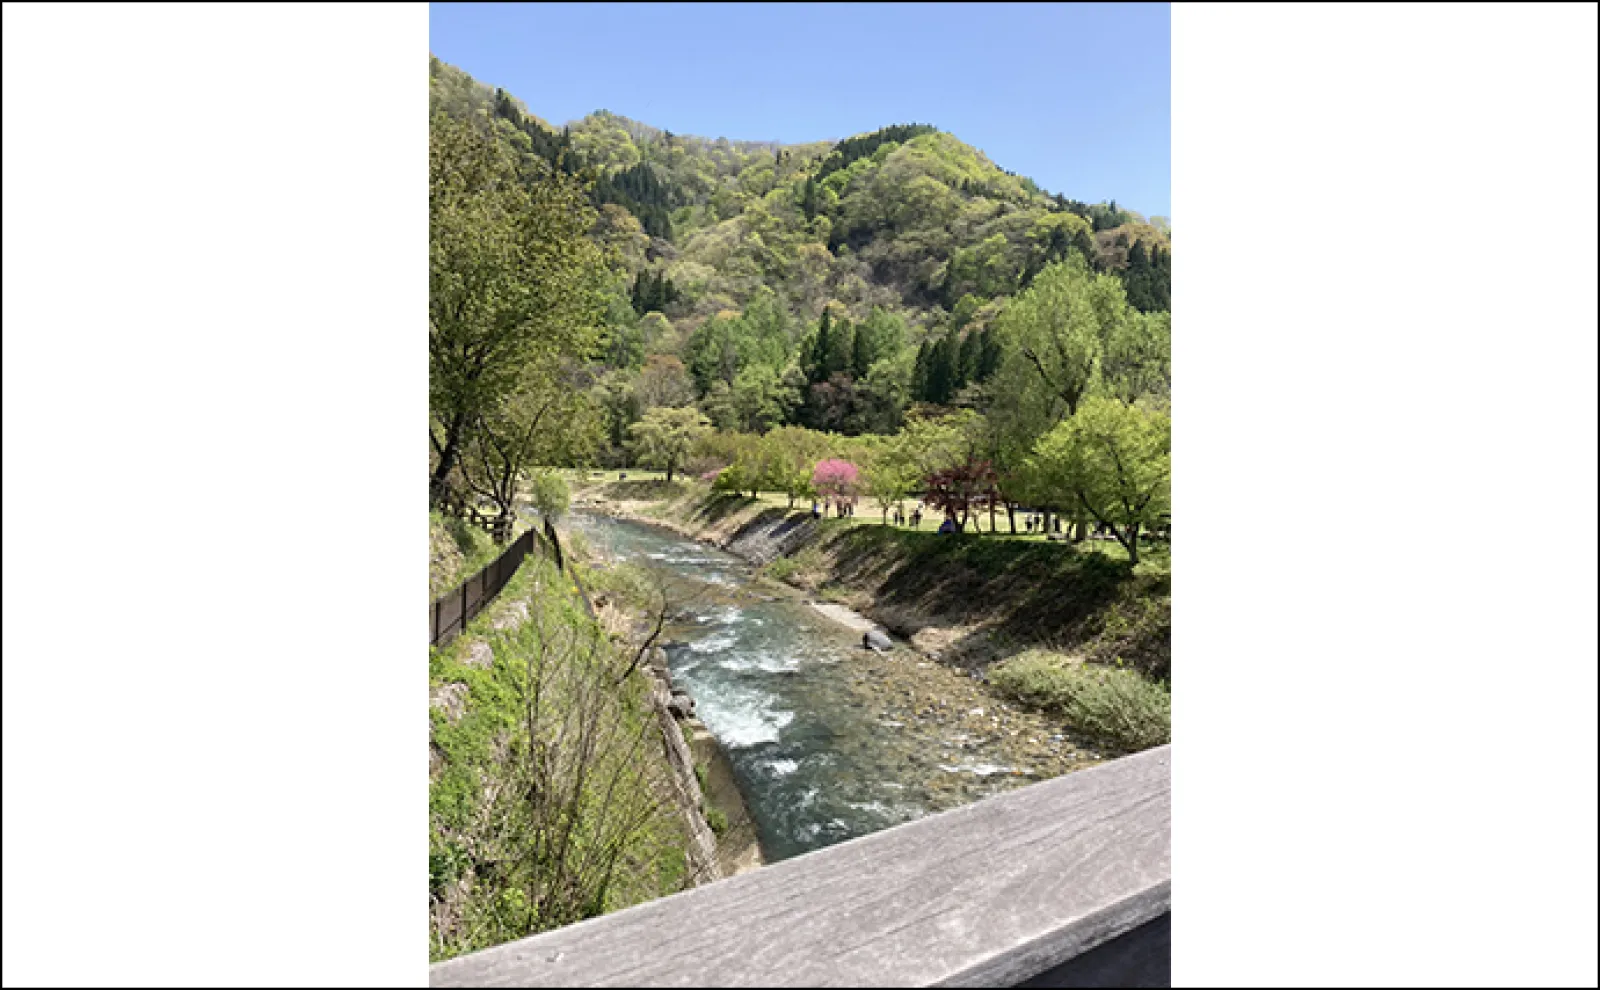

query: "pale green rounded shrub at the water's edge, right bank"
left=989, top=649, right=1173, bottom=752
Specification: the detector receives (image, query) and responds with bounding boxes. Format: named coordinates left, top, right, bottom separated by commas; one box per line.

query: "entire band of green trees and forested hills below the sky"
left=429, top=58, right=1171, bottom=555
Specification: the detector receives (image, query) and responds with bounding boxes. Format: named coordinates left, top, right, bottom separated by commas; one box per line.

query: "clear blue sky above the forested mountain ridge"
left=429, top=3, right=1171, bottom=216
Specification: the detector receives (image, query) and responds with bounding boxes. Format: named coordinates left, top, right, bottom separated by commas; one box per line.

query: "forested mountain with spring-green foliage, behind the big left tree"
left=429, top=59, right=1171, bottom=489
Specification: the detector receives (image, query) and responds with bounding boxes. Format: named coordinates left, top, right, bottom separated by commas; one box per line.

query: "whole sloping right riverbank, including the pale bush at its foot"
left=579, top=472, right=1171, bottom=752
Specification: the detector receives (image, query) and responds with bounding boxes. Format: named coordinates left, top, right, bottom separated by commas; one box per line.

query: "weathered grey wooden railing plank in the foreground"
left=429, top=747, right=1171, bottom=987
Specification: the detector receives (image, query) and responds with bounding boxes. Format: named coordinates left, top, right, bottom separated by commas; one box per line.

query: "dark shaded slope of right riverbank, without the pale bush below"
left=576, top=485, right=1171, bottom=680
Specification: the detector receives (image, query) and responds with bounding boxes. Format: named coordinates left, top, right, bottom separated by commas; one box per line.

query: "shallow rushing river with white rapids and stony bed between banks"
left=568, top=512, right=1091, bottom=862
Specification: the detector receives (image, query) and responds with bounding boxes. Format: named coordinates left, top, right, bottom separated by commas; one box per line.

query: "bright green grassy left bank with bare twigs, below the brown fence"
left=429, top=543, right=694, bottom=960
